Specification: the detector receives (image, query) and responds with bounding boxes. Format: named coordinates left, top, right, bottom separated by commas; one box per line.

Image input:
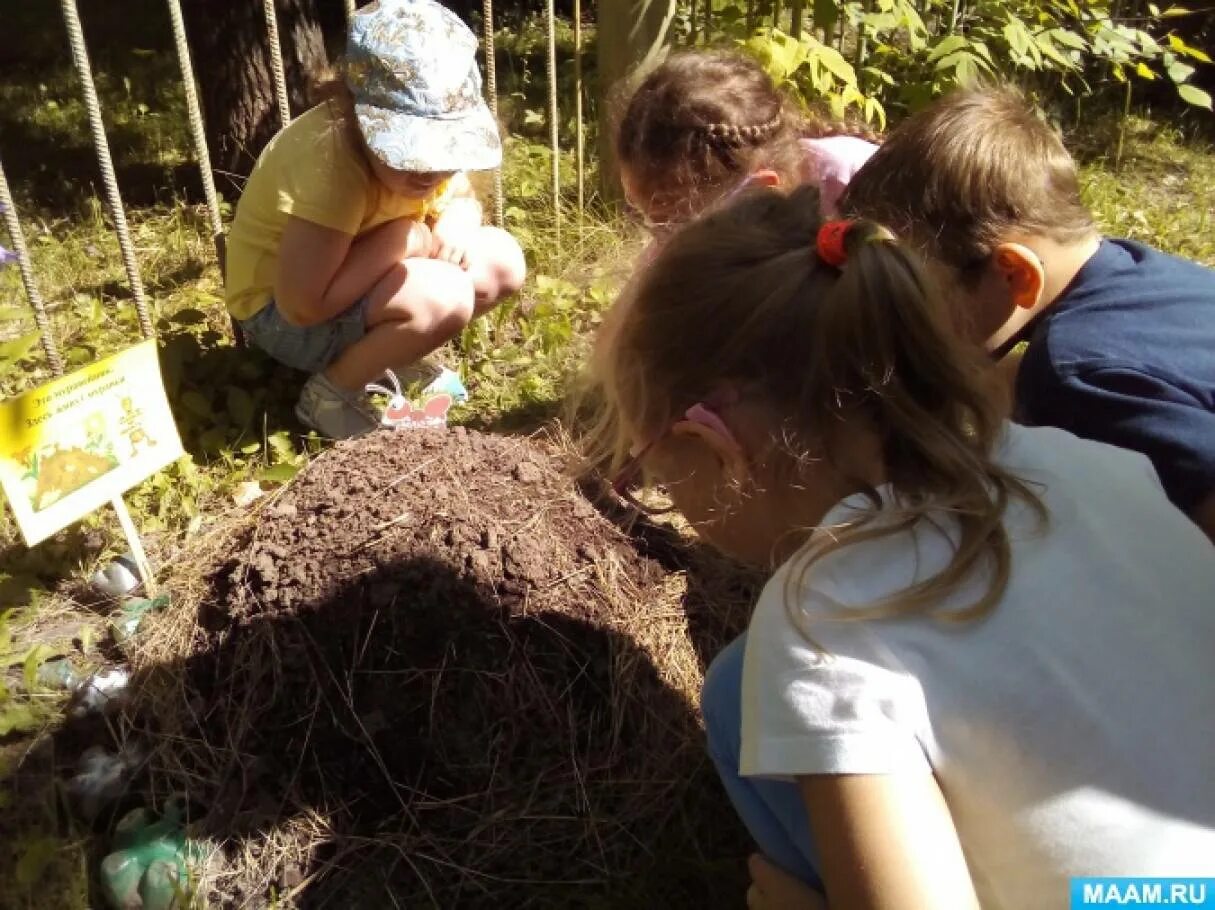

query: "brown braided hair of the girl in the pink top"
left=616, top=50, right=870, bottom=204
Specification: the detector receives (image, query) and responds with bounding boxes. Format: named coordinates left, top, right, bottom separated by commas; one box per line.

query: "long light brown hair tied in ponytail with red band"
left=594, top=187, right=1042, bottom=620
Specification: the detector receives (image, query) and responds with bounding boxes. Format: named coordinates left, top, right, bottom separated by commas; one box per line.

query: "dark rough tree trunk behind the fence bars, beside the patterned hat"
left=182, top=0, right=328, bottom=198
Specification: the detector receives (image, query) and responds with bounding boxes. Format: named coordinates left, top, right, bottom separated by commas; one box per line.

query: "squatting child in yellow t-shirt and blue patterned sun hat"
left=226, top=0, right=526, bottom=439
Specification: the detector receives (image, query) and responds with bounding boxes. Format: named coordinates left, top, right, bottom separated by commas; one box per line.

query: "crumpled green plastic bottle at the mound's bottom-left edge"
left=101, top=802, right=200, bottom=910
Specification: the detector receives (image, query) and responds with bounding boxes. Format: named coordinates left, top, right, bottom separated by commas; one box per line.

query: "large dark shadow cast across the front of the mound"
left=102, top=559, right=746, bottom=910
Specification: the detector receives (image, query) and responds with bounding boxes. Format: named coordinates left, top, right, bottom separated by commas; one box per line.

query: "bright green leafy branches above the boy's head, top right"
left=710, top=0, right=1211, bottom=128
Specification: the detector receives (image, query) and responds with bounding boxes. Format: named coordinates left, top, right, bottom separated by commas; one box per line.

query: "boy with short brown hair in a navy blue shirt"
left=841, top=87, right=1215, bottom=541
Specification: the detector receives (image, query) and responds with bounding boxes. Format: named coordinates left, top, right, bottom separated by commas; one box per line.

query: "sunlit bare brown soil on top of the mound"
left=203, top=428, right=662, bottom=628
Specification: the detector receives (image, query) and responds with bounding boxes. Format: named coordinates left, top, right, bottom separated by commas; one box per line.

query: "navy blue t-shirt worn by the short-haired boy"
left=1017, top=239, right=1215, bottom=511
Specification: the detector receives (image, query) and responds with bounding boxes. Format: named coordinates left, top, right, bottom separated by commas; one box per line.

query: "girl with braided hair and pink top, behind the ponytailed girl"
left=616, top=50, right=877, bottom=251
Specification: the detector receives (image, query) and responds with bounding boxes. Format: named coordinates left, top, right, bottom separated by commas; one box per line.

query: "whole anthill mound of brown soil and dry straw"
left=123, top=429, right=751, bottom=908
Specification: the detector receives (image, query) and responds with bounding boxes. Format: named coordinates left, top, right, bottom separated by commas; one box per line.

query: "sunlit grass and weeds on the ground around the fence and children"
left=0, top=5, right=1215, bottom=908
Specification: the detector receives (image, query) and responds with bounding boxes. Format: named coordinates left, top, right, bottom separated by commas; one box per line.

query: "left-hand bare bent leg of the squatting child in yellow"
left=324, top=259, right=476, bottom=390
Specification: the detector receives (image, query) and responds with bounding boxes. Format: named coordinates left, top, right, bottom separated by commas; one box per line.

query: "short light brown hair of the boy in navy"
left=840, top=85, right=1095, bottom=281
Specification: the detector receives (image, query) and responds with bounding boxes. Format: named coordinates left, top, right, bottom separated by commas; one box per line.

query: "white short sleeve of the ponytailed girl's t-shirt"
left=740, top=572, right=931, bottom=778
